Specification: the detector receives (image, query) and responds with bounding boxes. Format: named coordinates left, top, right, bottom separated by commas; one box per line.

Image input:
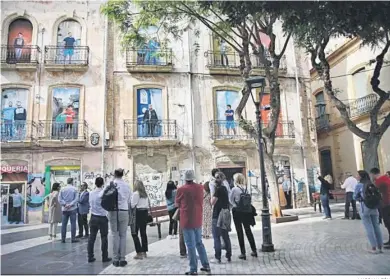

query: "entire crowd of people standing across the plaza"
left=49, top=168, right=390, bottom=275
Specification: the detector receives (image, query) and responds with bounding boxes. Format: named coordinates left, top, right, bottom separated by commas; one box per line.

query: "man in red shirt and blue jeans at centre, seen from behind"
left=176, top=170, right=210, bottom=275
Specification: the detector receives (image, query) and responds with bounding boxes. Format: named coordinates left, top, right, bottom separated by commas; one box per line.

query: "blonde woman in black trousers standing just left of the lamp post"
left=230, top=173, right=257, bottom=260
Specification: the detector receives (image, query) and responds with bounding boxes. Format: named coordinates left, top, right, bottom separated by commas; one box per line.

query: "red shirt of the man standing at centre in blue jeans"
left=175, top=182, right=203, bottom=229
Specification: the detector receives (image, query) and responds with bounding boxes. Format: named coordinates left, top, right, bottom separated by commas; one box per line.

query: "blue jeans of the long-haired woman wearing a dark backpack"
left=360, top=204, right=383, bottom=248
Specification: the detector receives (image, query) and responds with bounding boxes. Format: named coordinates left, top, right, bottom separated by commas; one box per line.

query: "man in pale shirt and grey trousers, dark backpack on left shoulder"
left=101, top=169, right=132, bottom=267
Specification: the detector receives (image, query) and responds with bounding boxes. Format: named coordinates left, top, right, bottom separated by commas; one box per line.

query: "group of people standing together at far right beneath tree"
left=318, top=168, right=390, bottom=254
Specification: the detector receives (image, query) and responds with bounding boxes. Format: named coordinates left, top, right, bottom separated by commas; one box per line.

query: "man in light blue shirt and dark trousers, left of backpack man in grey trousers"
left=87, top=177, right=112, bottom=263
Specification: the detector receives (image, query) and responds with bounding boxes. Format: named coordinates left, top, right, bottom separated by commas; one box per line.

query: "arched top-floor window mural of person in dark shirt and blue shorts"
left=55, top=20, right=82, bottom=64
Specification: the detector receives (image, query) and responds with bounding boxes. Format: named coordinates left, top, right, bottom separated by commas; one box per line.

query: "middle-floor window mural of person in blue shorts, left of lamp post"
left=216, top=90, right=241, bottom=137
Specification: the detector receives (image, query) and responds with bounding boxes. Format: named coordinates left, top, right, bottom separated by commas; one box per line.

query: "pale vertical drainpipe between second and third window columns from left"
left=100, top=16, right=108, bottom=176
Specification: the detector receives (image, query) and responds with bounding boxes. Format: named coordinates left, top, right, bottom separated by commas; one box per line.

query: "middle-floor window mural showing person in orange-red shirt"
left=52, top=87, right=80, bottom=139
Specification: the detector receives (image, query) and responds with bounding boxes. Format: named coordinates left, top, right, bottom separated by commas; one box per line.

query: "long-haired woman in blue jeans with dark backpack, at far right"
left=353, top=170, right=383, bottom=254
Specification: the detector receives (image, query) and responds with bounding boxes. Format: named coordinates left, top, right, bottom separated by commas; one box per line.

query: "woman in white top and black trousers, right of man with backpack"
left=131, top=180, right=149, bottom=260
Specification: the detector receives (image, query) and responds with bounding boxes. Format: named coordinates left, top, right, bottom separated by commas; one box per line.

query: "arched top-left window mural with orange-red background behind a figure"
left=7, top=18, right=33, bottom=64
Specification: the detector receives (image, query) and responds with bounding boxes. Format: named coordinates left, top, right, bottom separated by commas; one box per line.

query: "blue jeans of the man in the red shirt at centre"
left=183, top=228, right=210, bottom=272
